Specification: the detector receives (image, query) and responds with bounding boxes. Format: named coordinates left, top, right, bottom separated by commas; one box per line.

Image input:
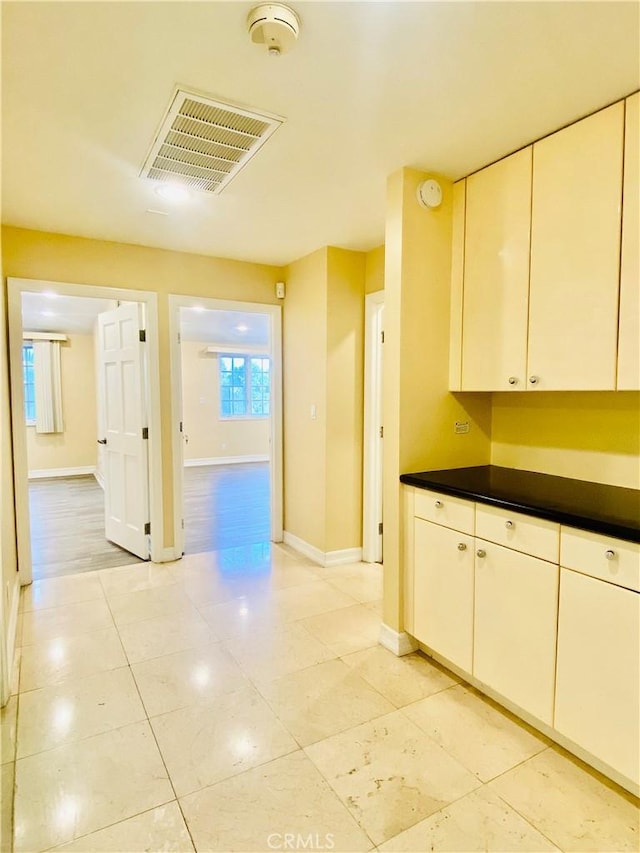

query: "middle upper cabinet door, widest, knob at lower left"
left=527, top=102, right=624, bottom=391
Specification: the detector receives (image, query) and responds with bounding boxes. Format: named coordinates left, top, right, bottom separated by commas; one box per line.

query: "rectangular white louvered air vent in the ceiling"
left=140, top=89, right=283, bottom=193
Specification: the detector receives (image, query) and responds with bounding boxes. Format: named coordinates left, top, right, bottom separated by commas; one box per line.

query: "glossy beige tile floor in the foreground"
left=1, top=546, right=639, bottom=853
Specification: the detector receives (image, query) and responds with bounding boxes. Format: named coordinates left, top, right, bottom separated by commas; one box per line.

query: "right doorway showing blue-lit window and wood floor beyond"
left=171, top=296, right=282, bottom=558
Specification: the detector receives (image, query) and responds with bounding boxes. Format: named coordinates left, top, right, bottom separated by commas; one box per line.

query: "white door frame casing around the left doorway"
left=7, top=278, right=162, bottom=586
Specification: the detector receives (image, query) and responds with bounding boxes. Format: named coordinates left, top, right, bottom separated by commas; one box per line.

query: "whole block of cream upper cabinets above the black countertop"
left=449, top=93, right=640, bottom=391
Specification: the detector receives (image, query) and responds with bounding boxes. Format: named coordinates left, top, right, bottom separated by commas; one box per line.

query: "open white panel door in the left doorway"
left=98, top=303, right=149, bottom=560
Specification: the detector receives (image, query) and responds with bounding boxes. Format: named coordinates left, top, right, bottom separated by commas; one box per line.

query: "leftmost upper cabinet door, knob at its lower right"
left=462, top=146, right=532, bottom=391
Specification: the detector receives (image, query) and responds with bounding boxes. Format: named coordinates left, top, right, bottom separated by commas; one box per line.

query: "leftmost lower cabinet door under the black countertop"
left=413, top=518, right=473, bottom=672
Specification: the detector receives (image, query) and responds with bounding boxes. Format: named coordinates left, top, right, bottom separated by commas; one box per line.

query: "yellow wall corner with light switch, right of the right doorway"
left=283, top=247, right=365, bottom=553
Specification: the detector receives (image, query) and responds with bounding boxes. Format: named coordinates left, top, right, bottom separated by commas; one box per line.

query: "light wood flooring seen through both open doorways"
left=29, top=462, right=270, bottom=580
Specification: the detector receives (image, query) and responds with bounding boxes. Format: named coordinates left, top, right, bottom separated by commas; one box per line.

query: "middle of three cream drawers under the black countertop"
left=476, top=504, right=560, bottom=563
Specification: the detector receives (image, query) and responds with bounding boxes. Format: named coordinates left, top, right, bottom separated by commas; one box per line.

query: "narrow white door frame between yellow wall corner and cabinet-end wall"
left=362, top=290, right=384, bottom=563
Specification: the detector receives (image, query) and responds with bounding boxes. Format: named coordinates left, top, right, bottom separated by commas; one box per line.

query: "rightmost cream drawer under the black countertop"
left=560, top=527, right=640, bottom=592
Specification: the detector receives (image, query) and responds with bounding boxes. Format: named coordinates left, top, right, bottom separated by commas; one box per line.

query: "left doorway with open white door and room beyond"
left=9, top=279, right=164, bottom=584
